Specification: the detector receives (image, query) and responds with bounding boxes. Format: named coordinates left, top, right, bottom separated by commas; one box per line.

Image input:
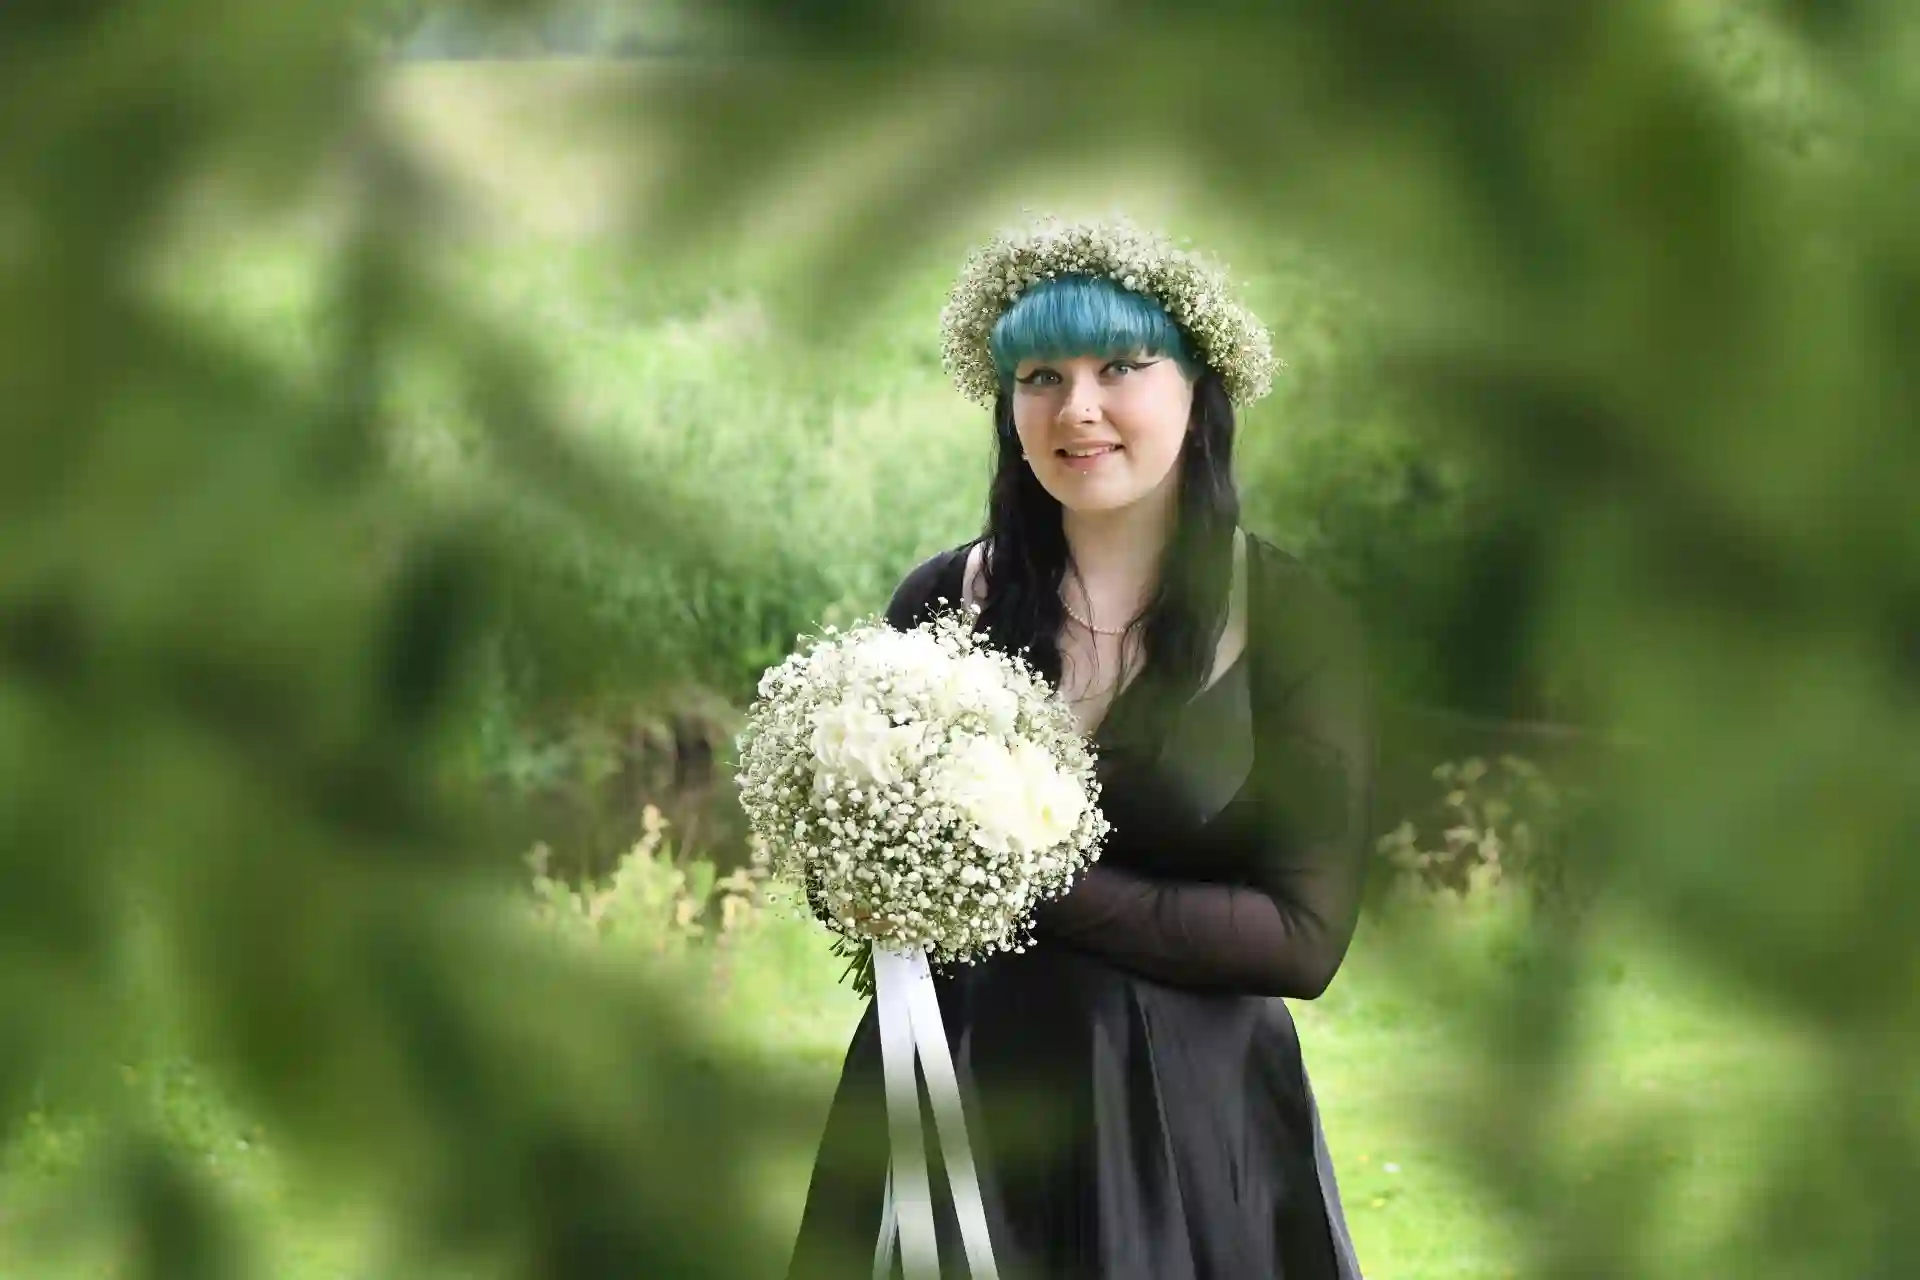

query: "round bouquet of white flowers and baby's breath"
left=739, top=610, right=1108, bottom=994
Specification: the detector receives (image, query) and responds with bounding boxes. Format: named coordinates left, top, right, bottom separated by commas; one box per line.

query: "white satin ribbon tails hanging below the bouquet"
left=874, top=946, right=998, bottom=1280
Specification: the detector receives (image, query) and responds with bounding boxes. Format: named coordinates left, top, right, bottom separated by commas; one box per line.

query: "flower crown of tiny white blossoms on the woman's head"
left=941, top=217, right=1283, bottom=407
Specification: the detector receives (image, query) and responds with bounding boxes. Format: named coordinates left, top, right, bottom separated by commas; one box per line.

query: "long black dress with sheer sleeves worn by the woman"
left=789, top=537, right=1375, bottom=1280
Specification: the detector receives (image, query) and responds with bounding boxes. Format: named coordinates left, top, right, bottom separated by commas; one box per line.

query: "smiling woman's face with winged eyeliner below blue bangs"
left=1012, top=355, right=1194, bottom=512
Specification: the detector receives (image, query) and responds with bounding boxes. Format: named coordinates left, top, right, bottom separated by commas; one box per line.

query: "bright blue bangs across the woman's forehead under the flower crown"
left=987, top=276, right=1200, bottom=388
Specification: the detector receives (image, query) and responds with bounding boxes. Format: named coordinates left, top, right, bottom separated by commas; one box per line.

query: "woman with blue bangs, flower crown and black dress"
left=789, top=223, right=1373, bottom=1280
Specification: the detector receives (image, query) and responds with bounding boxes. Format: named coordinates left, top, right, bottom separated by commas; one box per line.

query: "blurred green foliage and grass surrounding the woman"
left=0, top=0, right=1920, bottom=1280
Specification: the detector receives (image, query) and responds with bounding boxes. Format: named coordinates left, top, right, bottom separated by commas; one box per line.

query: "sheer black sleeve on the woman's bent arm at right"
left=1035, top=553, right=1375, bottom=1000
